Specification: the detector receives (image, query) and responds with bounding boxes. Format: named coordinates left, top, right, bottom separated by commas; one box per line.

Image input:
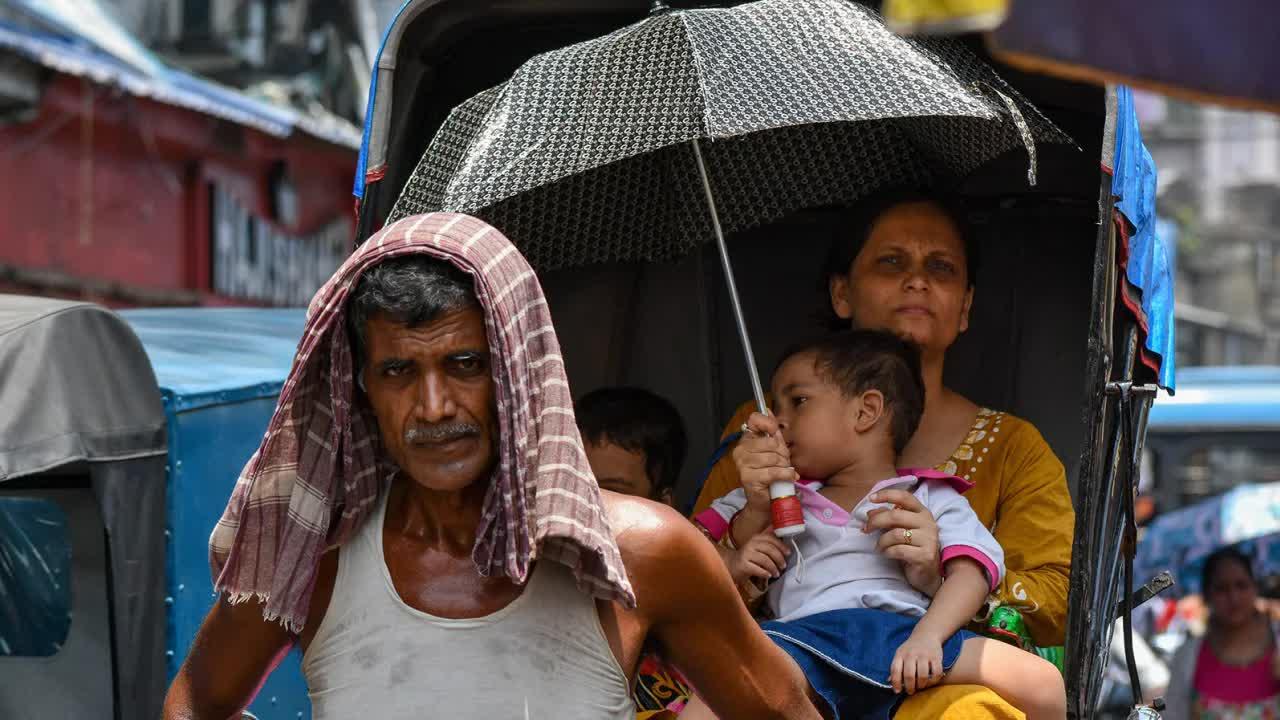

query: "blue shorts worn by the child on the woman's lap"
left=763, top=609, right=977, bottom=720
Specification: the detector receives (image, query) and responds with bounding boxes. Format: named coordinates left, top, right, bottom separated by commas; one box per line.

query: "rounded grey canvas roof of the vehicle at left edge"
left=0, top=295, right=165, bottom=482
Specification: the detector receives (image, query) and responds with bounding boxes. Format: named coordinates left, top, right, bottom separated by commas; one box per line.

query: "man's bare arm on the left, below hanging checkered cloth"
left=164, top=598, right=294, bottom=720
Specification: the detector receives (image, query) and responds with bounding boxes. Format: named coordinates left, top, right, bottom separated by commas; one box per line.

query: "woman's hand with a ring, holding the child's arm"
left=863, top=489, right=942, bottom=597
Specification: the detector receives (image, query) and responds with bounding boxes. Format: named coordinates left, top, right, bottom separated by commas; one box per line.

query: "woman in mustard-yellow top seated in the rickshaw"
left=694, top=191, right=1075, bottom=717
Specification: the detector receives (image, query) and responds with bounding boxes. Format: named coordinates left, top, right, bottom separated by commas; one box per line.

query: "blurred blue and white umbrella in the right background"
left=1134, top=483, right=1280, bottom=593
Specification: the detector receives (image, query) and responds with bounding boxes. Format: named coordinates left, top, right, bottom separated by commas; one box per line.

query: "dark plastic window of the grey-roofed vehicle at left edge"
left=0, top=497, right=72, bottom=657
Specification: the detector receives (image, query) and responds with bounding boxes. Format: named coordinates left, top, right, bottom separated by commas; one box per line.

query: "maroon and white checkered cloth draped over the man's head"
left=209, top=213, right=635, bottom=632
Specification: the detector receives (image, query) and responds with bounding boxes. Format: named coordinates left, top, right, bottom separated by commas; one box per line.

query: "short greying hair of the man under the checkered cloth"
left=347, top=255, right=477, bottom=373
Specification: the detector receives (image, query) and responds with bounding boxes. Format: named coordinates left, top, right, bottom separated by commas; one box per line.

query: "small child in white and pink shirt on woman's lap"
left=681, top=331, right=1066, bottom=720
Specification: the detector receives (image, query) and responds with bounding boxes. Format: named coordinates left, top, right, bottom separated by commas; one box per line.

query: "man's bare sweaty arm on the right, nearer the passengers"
left=618, top=503, right=819, bottom=720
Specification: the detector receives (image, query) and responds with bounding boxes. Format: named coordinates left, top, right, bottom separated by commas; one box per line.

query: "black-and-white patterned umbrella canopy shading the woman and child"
left=389, top=0, right=1070, bottom=270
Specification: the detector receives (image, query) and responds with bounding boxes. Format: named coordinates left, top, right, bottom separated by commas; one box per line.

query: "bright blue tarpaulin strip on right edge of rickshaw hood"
left=1111, top=87, right=1175, bottom=391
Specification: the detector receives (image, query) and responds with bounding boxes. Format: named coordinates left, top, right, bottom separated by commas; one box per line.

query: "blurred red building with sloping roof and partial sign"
left=0, top=3, right=360, bottom=306
